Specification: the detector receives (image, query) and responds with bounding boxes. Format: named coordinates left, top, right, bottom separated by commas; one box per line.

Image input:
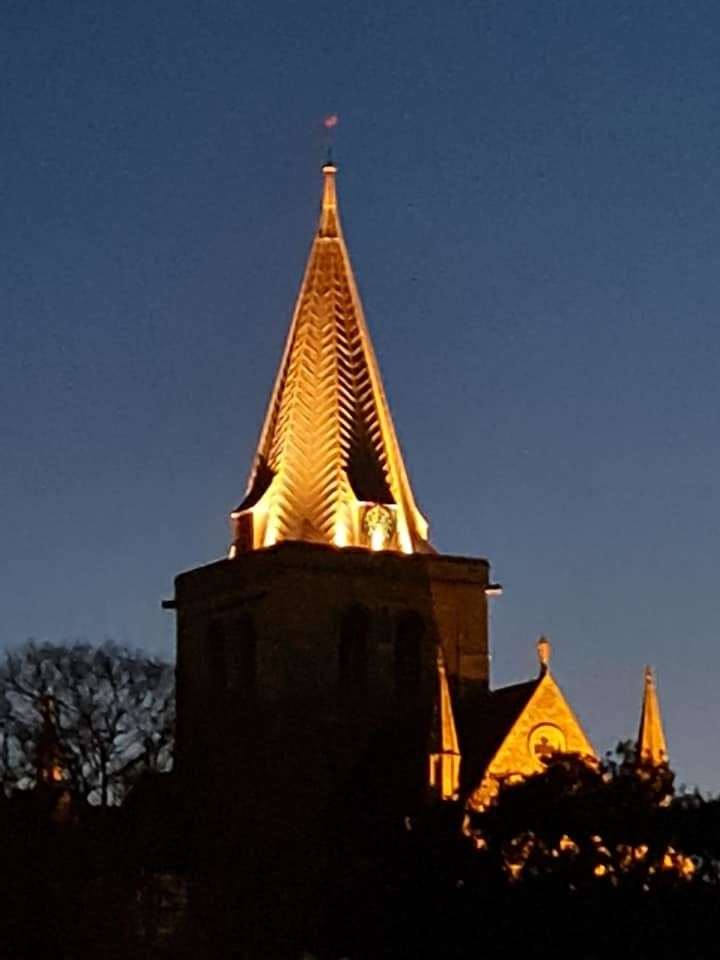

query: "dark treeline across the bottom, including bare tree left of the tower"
left=0, top=644, right=720, bottom=960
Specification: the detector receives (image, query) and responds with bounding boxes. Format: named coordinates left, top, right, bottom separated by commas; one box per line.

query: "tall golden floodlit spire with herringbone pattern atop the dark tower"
left=230, top=163, right=431, bottom=556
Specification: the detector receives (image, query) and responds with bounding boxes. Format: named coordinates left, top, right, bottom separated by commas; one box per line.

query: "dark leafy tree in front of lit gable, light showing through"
left=470, top=744, right=697, bottom=890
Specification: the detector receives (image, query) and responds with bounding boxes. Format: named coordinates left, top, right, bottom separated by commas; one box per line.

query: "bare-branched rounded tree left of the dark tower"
left=0, top=642, right=175, bottom=806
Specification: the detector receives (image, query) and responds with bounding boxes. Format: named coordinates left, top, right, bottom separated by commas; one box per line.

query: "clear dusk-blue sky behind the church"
left=0, top=0, right=720, bottom=790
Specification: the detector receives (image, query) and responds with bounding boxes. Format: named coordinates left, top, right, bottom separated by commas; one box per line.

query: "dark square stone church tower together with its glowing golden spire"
left=168, top=164, right=491, bottom=807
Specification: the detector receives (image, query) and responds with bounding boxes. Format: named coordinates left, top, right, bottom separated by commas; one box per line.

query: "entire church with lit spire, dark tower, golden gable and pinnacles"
left=166, top=163, right=667, bottom=948
